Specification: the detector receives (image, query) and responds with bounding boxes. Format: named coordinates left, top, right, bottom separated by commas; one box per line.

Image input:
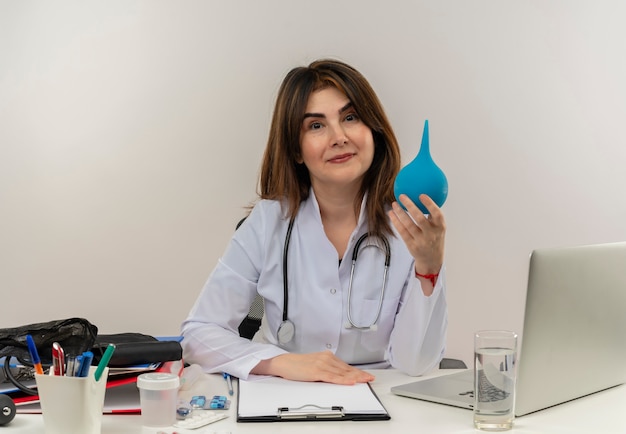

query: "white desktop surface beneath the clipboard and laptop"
left=9, top=370, right=626, bottom=434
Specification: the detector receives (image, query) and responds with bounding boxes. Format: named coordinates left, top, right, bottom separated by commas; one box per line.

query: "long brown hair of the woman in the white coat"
left=259, top=60, right=400, bottom=235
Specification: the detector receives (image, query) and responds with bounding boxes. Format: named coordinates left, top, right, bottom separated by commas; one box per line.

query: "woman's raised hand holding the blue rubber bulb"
left=389, top=194, right=446, bottom=275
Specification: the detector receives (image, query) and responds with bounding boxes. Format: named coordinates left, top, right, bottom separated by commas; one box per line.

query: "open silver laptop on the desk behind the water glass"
left=391, top=242, right=626, bottom=416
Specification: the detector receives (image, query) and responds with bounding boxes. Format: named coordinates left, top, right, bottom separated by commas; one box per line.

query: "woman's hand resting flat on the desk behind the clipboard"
left=251, top=351, right=374, bottom=384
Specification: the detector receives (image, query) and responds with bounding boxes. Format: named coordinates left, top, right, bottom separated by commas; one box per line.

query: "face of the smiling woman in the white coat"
left=298, top=87, right=374, bottom=192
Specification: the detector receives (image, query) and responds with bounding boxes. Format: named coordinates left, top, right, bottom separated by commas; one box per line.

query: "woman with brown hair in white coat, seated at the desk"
left=182, top=60, right=447, bottom=384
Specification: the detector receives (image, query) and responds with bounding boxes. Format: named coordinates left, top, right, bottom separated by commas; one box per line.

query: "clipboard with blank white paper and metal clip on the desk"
left=237, top=377, right=391, bottom=422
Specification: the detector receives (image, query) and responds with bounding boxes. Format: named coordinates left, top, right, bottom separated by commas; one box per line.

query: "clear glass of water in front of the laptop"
left=474, top=330, right=517, bottom=431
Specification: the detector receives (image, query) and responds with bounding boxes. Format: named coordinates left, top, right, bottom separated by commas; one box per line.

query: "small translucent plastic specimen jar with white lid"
left=137, top=372, right=180, bottom=427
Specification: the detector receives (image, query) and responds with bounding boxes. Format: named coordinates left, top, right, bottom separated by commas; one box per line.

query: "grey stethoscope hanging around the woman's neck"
left=276, top=218, right=391, bottom=344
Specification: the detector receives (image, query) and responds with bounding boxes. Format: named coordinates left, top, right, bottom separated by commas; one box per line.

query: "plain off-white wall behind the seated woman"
left=0, top=0, right=626, bottom=364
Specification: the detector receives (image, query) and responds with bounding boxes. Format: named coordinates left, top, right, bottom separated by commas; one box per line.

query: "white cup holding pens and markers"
left=35, top=366, right=109, bottom=434
